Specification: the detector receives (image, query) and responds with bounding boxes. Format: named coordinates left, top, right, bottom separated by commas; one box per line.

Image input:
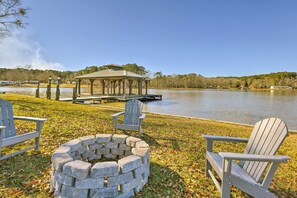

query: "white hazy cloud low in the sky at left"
left=0, top=33, right=65, bottom=70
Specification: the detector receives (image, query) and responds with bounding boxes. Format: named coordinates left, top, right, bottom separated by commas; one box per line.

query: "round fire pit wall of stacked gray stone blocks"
left=50, top=134, right=150, bottom=198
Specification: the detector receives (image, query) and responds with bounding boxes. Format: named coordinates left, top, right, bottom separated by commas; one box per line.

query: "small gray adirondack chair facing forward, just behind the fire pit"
left=112, top=99, right=145, bottom=135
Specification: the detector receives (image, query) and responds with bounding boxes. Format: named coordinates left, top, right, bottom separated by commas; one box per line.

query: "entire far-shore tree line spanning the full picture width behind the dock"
left=0, top=63, right=297, bottom=89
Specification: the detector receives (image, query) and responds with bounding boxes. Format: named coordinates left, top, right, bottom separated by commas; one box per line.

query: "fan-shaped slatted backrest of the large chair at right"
left=241, top=118, right=288, bottom=182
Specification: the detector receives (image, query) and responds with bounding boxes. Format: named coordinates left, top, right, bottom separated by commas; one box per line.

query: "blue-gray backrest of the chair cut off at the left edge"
left=0, top=99, right=16, bottom=138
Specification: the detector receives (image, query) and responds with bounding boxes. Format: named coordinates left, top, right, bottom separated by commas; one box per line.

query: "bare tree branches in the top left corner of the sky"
left=0, top=0, right=27, bottom=39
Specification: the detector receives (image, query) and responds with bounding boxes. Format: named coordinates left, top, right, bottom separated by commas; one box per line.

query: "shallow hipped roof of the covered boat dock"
left=75, top=69, right=147, bottom=79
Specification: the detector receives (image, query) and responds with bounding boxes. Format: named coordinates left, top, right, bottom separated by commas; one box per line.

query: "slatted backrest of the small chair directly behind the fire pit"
left=124, top=100, right=141, bottom=125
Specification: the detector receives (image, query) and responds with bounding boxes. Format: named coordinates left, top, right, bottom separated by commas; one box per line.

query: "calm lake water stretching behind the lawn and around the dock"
left=0, top=87, right=297, bottom=130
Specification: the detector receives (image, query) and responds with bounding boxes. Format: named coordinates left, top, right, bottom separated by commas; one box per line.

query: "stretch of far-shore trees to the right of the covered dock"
left=151, top=72, right=297, bottom=89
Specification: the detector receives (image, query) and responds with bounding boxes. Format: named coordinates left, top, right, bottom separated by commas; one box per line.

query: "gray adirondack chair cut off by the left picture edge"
left=0, top=99, right=46, bottom=160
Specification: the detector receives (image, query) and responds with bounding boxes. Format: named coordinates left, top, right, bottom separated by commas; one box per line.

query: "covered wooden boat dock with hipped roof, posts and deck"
left=60, top=66, right=162, bottom=102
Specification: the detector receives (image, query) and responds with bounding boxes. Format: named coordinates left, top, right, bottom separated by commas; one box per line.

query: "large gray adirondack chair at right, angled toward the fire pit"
left=203, top=118, right=290, bottom=198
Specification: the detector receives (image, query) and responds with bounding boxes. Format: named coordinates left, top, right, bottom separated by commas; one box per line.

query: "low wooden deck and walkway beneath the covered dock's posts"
left=60, top=94, right=162, bottom=103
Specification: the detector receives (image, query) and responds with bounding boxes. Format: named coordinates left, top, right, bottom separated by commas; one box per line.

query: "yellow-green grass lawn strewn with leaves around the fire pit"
left=0, top=94, right=297, bottom=197
